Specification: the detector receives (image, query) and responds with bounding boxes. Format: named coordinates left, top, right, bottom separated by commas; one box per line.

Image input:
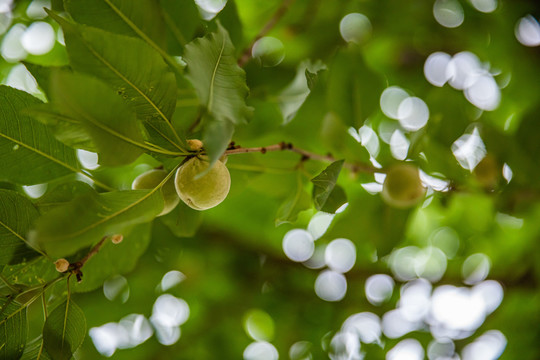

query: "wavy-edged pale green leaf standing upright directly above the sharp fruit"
left=184, top=23, right=251, bottom=162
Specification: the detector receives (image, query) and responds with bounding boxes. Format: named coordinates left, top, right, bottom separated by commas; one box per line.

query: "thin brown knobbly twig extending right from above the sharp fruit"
left=224, top=142, right=378, bottom=173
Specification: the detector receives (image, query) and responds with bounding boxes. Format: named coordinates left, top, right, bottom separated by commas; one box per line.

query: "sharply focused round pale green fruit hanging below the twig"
left=174, top=157, right=231, bottom=210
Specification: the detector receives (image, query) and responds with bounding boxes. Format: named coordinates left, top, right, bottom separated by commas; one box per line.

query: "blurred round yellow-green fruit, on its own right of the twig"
left=381, top=164, right=426, bottom=209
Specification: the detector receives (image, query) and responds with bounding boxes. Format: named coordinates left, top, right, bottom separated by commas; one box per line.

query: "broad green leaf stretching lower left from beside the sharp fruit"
left=30, top=187, right=163, bottom=257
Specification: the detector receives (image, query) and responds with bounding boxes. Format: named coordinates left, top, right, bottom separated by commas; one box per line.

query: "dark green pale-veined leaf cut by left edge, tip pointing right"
left=0, top=86, right=80, bottom=185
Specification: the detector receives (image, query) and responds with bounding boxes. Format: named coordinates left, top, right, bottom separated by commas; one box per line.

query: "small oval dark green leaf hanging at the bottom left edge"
left=43, top=295, right=86, bottom=360
